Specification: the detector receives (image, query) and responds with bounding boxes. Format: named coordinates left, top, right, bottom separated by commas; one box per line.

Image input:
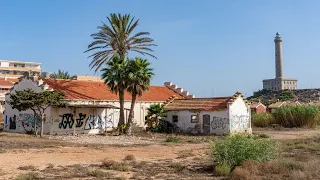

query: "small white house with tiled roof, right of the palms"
left=165, top=93, right=252, bottom=135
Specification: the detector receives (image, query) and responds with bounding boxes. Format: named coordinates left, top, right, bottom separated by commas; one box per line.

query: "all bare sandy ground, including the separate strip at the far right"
left=0, top=129, right=320, bottom=179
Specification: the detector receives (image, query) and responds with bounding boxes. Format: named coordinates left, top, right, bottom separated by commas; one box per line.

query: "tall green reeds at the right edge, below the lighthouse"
left=273, top=105, right=320, bottom=128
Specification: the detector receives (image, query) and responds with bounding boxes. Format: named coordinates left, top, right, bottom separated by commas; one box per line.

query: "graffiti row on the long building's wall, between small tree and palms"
left=59, top=111, right=119, bottom=130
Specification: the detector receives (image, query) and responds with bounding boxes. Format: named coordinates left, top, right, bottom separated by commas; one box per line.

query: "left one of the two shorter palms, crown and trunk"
left=101, top=56, right=128, bottom=127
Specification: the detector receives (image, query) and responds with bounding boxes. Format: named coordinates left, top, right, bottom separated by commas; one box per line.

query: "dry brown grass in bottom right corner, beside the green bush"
left=231, top=136, right=320, bottom=180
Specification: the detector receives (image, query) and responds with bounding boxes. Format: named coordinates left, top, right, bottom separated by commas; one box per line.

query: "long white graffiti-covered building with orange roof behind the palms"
left=4, top=78, right=192, bottom=135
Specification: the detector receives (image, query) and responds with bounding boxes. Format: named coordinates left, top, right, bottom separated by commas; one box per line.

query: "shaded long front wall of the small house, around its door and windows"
left=166, top=110, right=230, bottom=135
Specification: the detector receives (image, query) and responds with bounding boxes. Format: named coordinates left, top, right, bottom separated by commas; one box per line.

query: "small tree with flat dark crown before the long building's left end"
left=8, top=89, right=66, bottom=136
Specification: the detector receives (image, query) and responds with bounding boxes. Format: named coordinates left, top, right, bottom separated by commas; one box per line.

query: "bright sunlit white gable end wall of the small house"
left=229, top=97, right=252, bottom=133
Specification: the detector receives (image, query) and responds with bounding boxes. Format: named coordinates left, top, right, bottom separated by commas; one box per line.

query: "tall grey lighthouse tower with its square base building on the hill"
left=262, top=33, right=298, bottom=91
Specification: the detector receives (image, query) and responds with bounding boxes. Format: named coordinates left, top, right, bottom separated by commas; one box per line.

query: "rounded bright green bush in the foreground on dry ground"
left=212, top=135, right=277, bottom=168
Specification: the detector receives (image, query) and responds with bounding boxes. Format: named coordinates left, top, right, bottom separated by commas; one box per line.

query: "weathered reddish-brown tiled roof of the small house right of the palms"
left=165, top=97, right=232, bottom=111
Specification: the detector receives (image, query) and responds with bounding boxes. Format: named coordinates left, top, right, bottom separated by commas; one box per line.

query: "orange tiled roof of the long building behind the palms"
left=43, top=79, right=183, bottom=101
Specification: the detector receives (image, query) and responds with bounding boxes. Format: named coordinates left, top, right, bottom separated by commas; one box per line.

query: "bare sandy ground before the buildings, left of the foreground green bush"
left=0, top=135, right=209, bottom=179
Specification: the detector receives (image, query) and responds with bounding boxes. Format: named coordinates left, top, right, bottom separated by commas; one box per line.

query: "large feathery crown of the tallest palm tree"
left=85, top=13, right=156, bottom=72
